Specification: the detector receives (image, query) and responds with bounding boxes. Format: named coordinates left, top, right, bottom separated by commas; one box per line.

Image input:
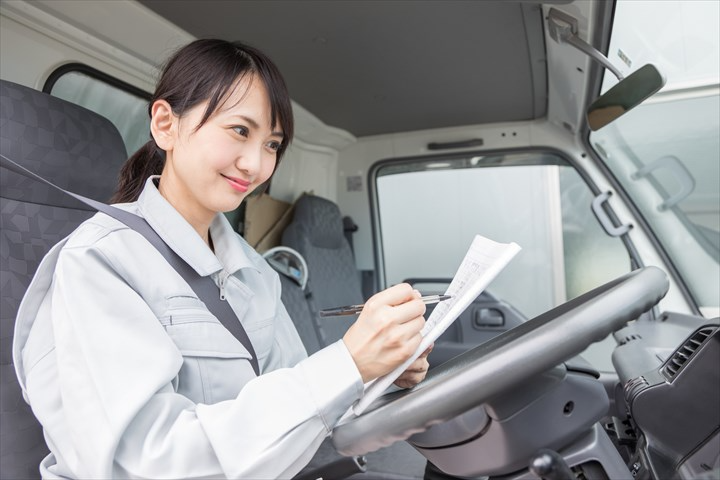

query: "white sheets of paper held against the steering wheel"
left=346, top=235, right=520, bottom=416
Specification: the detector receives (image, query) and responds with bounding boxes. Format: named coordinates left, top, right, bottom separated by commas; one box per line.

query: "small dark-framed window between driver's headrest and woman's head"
left=43, top=64, right=150, bottom=155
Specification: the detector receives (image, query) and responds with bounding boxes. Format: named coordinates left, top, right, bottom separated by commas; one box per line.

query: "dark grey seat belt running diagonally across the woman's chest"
left=0, top=153, right=260, bottom=376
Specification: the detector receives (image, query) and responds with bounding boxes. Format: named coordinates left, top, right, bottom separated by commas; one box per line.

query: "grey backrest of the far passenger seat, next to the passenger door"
left=282, top=194, right=363, bottom=345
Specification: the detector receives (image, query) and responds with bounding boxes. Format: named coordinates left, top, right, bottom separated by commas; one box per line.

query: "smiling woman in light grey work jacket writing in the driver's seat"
left=14, top=40, right=427, bottom=478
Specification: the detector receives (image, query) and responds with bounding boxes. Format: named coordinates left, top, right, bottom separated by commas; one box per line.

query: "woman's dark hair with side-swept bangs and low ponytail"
left=111, top=39, right=293, bottom=203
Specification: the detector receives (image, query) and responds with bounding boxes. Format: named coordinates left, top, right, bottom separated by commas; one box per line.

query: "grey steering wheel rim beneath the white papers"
left=332, top=267, right=669, bottom=456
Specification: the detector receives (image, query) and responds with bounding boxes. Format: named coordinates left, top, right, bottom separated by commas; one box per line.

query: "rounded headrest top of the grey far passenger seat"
left=293, top=195, right=345, bottom=249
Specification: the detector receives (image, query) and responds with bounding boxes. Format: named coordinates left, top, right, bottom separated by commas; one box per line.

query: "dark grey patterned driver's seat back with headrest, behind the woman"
left=0, top=80, right=127, bottom=478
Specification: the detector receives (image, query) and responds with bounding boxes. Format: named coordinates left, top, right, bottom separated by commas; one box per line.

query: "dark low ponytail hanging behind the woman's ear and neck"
left=110, top=140, right=165, bottom=203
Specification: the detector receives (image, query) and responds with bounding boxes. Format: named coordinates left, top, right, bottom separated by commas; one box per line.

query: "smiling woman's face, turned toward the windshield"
left=160, top=76, right=283, bottom=228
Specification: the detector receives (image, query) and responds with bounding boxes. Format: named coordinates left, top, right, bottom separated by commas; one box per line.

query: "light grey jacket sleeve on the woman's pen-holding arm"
left=42, top=233, right=362, bottom=478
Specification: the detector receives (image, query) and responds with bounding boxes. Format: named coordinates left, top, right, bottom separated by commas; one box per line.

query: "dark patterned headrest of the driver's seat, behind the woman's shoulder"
left=0, top=80, right=127, bottom=209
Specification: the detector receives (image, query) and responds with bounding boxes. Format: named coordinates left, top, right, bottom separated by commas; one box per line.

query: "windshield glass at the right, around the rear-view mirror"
left=590, top=0, right=720, bottom=318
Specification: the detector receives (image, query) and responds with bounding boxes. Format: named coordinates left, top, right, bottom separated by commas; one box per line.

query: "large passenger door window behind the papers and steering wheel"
left=373, top=152, right=631, bottom=318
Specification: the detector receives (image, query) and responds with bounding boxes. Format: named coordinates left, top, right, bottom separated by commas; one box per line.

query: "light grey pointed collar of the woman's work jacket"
left=137, top=175, right=258, bottom=277
